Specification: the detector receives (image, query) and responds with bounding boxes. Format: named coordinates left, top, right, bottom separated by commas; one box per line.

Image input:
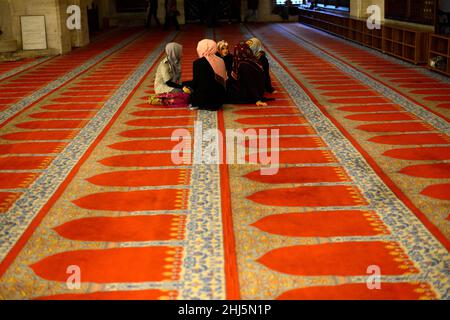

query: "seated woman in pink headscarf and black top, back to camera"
left=190, top=39, right=228, bottom=110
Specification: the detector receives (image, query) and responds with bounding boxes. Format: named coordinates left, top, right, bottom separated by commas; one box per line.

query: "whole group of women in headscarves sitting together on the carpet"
left=150, top=38, right=275, bottom=110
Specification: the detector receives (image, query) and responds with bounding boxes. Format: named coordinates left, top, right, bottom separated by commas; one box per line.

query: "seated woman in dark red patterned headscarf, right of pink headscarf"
left=228, top=43, right=267, bottom=106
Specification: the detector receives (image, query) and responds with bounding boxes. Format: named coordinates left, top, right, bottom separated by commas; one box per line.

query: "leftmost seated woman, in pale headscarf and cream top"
left=155, top=42, right=183, bottom=94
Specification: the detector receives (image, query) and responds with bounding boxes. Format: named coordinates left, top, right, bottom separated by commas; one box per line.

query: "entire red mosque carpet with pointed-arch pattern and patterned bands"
left=0, top=24, right=450, bottom=299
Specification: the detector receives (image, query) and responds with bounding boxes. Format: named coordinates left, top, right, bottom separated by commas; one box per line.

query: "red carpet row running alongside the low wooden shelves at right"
left=283, top=24, right=450, bottom=121
